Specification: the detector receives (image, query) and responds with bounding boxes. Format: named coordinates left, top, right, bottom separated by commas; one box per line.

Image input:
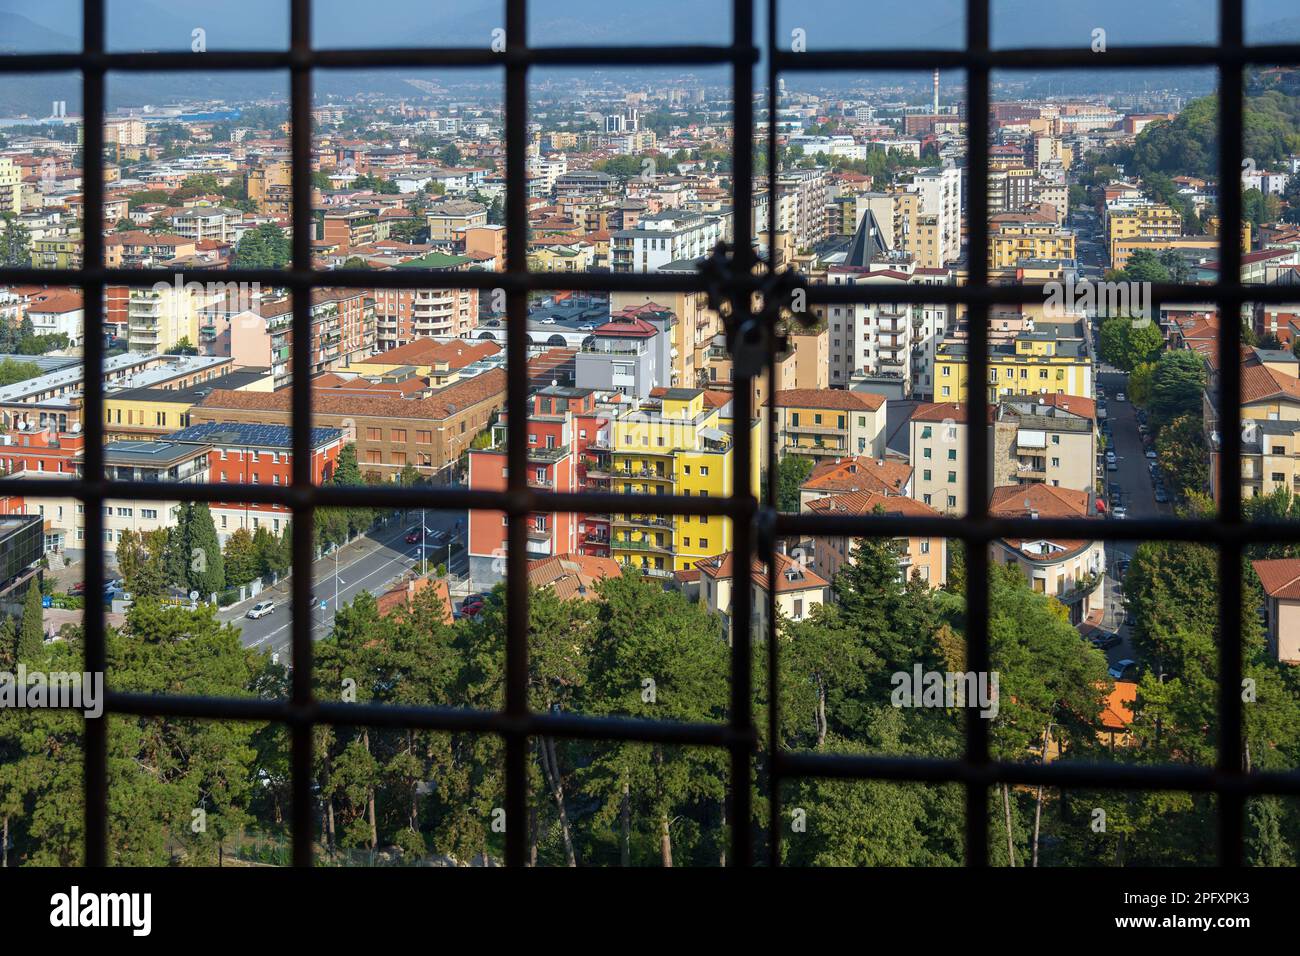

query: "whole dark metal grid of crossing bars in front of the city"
left=0, top=0, right=1300, bottom=866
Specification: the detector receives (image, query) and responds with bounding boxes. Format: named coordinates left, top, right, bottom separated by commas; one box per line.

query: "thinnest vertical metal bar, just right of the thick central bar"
left=764, top=0, right=781, bottom=869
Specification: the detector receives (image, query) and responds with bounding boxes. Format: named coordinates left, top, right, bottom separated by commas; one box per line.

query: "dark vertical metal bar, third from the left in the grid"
left=506, top=0, right=529, bottom=866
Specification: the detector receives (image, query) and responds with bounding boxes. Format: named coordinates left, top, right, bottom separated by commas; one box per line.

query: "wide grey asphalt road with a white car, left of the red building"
left=226, top=511, right=465, bottom=662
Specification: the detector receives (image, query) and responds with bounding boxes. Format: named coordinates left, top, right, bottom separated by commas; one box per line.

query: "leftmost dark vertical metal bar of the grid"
left=82, top=0, right=109, bottom=866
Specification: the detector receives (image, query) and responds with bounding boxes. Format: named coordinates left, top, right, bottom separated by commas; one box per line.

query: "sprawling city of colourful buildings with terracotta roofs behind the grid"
left=0, top=14, right=1300, bottom=864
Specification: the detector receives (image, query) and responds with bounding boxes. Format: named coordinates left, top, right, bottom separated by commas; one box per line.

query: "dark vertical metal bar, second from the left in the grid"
left=290, top=0, right=315, bottom=866
